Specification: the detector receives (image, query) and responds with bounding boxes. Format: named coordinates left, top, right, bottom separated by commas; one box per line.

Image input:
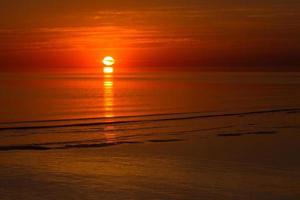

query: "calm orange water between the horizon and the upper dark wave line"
left=0, top=72, right=300, bottom=122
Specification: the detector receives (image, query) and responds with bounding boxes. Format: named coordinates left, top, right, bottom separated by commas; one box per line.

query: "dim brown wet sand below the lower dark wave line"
left=0, top=110, right=300, bottom=200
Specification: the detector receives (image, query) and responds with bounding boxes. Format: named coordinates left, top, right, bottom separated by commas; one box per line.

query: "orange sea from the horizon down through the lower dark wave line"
left=0, top=72, right=300, bottom=148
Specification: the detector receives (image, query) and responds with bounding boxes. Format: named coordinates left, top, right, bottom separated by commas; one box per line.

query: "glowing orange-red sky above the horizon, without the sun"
left=0, top=0, right=300, bottom=72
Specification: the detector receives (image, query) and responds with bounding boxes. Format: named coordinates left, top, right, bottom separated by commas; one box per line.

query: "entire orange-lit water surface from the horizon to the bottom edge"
left=0, top=72, right=300, bottom=199
